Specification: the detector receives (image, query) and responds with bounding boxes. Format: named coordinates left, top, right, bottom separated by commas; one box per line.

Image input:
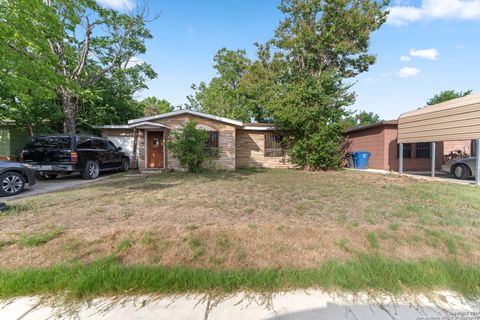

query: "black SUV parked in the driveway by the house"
left=21, top=135, right=130, bottom=179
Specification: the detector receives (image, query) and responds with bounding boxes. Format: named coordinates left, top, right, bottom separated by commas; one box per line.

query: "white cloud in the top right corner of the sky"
left=387, top=0, right=480, bottom=26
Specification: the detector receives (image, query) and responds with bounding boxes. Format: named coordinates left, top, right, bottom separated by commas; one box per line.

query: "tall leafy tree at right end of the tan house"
left=268, top=0, right=387, bottom=170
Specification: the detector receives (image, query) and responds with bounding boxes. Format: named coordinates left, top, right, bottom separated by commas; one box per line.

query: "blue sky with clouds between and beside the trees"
left=99, top=0, right=480, bottom=119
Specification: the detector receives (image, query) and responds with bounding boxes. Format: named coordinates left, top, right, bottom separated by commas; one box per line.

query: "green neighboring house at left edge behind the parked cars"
left=0, top=120, right=30, bottom=160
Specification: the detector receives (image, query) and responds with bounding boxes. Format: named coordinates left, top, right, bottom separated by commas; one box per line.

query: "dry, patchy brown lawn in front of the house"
left=0, top=170, right=480, bottom=269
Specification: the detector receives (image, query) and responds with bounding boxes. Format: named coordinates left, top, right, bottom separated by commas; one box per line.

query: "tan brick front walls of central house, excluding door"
left=102, top=112, right=293, bottom=171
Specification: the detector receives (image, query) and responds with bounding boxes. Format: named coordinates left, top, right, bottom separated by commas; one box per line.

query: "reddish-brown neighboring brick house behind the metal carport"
left=346, top=120, right=472, bottom=171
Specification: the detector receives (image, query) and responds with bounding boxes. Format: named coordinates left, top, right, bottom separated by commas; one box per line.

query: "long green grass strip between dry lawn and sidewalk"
left=0, top=255, right=480, bottom=298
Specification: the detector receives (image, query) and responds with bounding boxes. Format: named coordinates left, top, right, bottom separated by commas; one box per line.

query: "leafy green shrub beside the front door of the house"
left=168, top=120, right=208, bottom=172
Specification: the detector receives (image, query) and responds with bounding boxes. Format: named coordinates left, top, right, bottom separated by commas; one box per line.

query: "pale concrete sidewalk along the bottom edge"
left=0, top=290, right=480, bottom=320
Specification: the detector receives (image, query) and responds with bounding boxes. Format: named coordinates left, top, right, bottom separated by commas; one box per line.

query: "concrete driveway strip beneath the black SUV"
left=0, top=173, right=112, bottom=202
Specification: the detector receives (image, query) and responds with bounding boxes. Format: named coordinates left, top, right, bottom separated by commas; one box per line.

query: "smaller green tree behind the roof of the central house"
left=187, top=48, right=255, bottom=122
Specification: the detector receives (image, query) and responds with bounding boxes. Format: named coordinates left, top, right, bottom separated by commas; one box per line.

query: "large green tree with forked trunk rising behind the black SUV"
left=0, top=0, right=156, bottom=133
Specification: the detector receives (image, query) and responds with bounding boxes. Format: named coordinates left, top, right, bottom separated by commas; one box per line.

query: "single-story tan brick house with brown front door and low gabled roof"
left=100, top=110, right=293, bottom=170
